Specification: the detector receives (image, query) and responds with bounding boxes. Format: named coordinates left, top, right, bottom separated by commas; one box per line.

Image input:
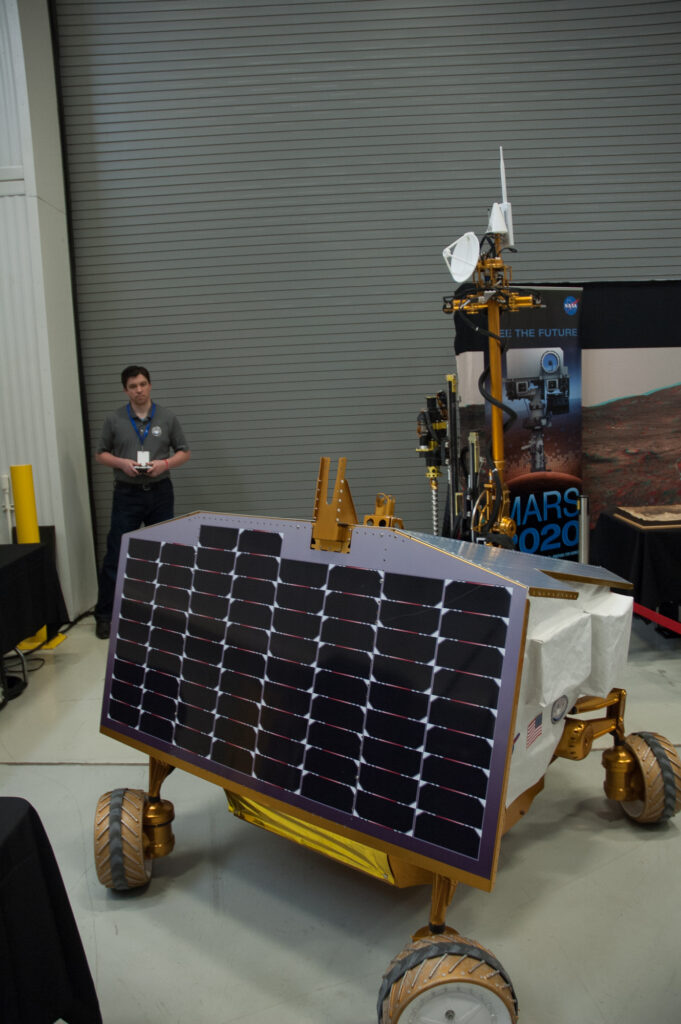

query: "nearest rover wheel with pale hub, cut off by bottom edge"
left=378, top=935, right=518, bottom=1024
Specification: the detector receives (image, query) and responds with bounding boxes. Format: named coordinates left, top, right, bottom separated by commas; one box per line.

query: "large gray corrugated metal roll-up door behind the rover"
left=53, top=0, right=681, bottom=561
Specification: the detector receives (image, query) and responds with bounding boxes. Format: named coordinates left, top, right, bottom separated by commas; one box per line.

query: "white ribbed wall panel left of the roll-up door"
left=0, top=0, right=95, bottom=616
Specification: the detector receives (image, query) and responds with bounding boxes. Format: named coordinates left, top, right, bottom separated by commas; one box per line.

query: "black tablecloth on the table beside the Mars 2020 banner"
left=589, top=509, right=681, bottom=608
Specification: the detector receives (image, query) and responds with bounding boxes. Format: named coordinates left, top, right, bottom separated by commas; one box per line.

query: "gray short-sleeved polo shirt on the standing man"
left=97, top=406, right=189, bottom=486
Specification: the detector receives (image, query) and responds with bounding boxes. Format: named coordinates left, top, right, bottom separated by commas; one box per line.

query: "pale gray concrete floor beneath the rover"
left=0, top=618, right=681, bottom=1024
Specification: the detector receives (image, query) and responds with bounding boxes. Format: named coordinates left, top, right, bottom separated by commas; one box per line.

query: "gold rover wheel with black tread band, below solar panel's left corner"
left=94, top=790, right=152, bottom=892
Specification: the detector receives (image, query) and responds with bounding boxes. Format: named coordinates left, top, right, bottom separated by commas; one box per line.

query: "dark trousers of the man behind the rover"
left=94, top=477, right=175, bottom=620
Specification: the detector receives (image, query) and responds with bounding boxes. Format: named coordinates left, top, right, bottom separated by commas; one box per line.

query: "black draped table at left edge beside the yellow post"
left=0, top=544, right=69, bottom=705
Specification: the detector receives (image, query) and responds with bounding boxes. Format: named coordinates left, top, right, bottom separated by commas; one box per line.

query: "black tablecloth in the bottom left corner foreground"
left=0, top=797, right=101, bottom=1024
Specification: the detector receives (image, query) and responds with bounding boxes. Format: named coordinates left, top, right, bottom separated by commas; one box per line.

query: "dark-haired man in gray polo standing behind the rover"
left=94, top=367, right=190, bottom=640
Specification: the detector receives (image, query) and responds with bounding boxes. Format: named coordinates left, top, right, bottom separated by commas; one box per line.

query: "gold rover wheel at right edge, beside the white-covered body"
left=622, top=732, right=681, bottom=824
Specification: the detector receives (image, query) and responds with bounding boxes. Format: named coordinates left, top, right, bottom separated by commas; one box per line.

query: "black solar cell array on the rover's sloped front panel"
left=103, top=524, right=511, bottom=876
